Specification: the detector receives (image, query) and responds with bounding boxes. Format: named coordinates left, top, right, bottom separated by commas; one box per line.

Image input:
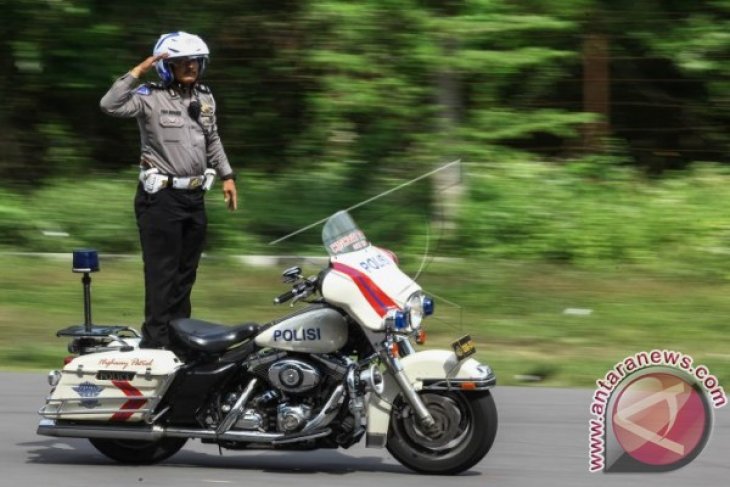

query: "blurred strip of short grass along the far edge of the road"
left=0, top=255, right=730, bottom=387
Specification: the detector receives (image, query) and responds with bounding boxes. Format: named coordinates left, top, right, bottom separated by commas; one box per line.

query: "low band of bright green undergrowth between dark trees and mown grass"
left=0, top=158, right=730, bottom=288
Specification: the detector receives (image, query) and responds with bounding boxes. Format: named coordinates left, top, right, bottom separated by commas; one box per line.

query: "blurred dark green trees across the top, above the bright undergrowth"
left=0, top=0, right=730, bottom=252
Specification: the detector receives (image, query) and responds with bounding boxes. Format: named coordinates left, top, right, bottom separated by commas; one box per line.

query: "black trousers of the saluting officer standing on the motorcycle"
left=134, top=184, right=208, bottom=347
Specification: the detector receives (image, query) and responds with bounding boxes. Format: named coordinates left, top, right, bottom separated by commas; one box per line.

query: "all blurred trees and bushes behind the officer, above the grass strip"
left=0, top=0, right=730, bottom=268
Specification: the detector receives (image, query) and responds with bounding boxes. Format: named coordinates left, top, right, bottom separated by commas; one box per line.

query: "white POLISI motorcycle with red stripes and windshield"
left=37, top=211, right=497, bottom=475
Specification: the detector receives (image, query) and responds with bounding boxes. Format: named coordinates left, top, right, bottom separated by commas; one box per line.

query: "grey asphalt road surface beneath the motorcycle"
left=0, top=372, right=730, bottom=487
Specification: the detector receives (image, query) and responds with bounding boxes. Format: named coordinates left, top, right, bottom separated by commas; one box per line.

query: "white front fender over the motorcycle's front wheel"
left=366, top=350, right=497, bottom=447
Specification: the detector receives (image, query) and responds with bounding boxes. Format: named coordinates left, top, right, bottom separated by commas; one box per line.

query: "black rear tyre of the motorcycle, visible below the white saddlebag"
left=89, top=438, right=188, bottom=465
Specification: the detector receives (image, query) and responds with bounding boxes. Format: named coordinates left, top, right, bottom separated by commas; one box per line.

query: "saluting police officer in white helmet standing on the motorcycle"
left=100, top=32, right=238, bottom=348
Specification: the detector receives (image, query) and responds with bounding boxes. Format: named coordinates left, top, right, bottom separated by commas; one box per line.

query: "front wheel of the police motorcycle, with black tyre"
left=387, top=391, right=497, bottom=475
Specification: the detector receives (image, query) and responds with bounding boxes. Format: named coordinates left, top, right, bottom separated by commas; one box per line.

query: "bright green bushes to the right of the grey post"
left=456, top=157, right=730, bottom=276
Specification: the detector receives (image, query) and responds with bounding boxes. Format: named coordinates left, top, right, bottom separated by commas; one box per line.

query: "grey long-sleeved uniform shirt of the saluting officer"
left=100, top=73, right=233, bottom=177
